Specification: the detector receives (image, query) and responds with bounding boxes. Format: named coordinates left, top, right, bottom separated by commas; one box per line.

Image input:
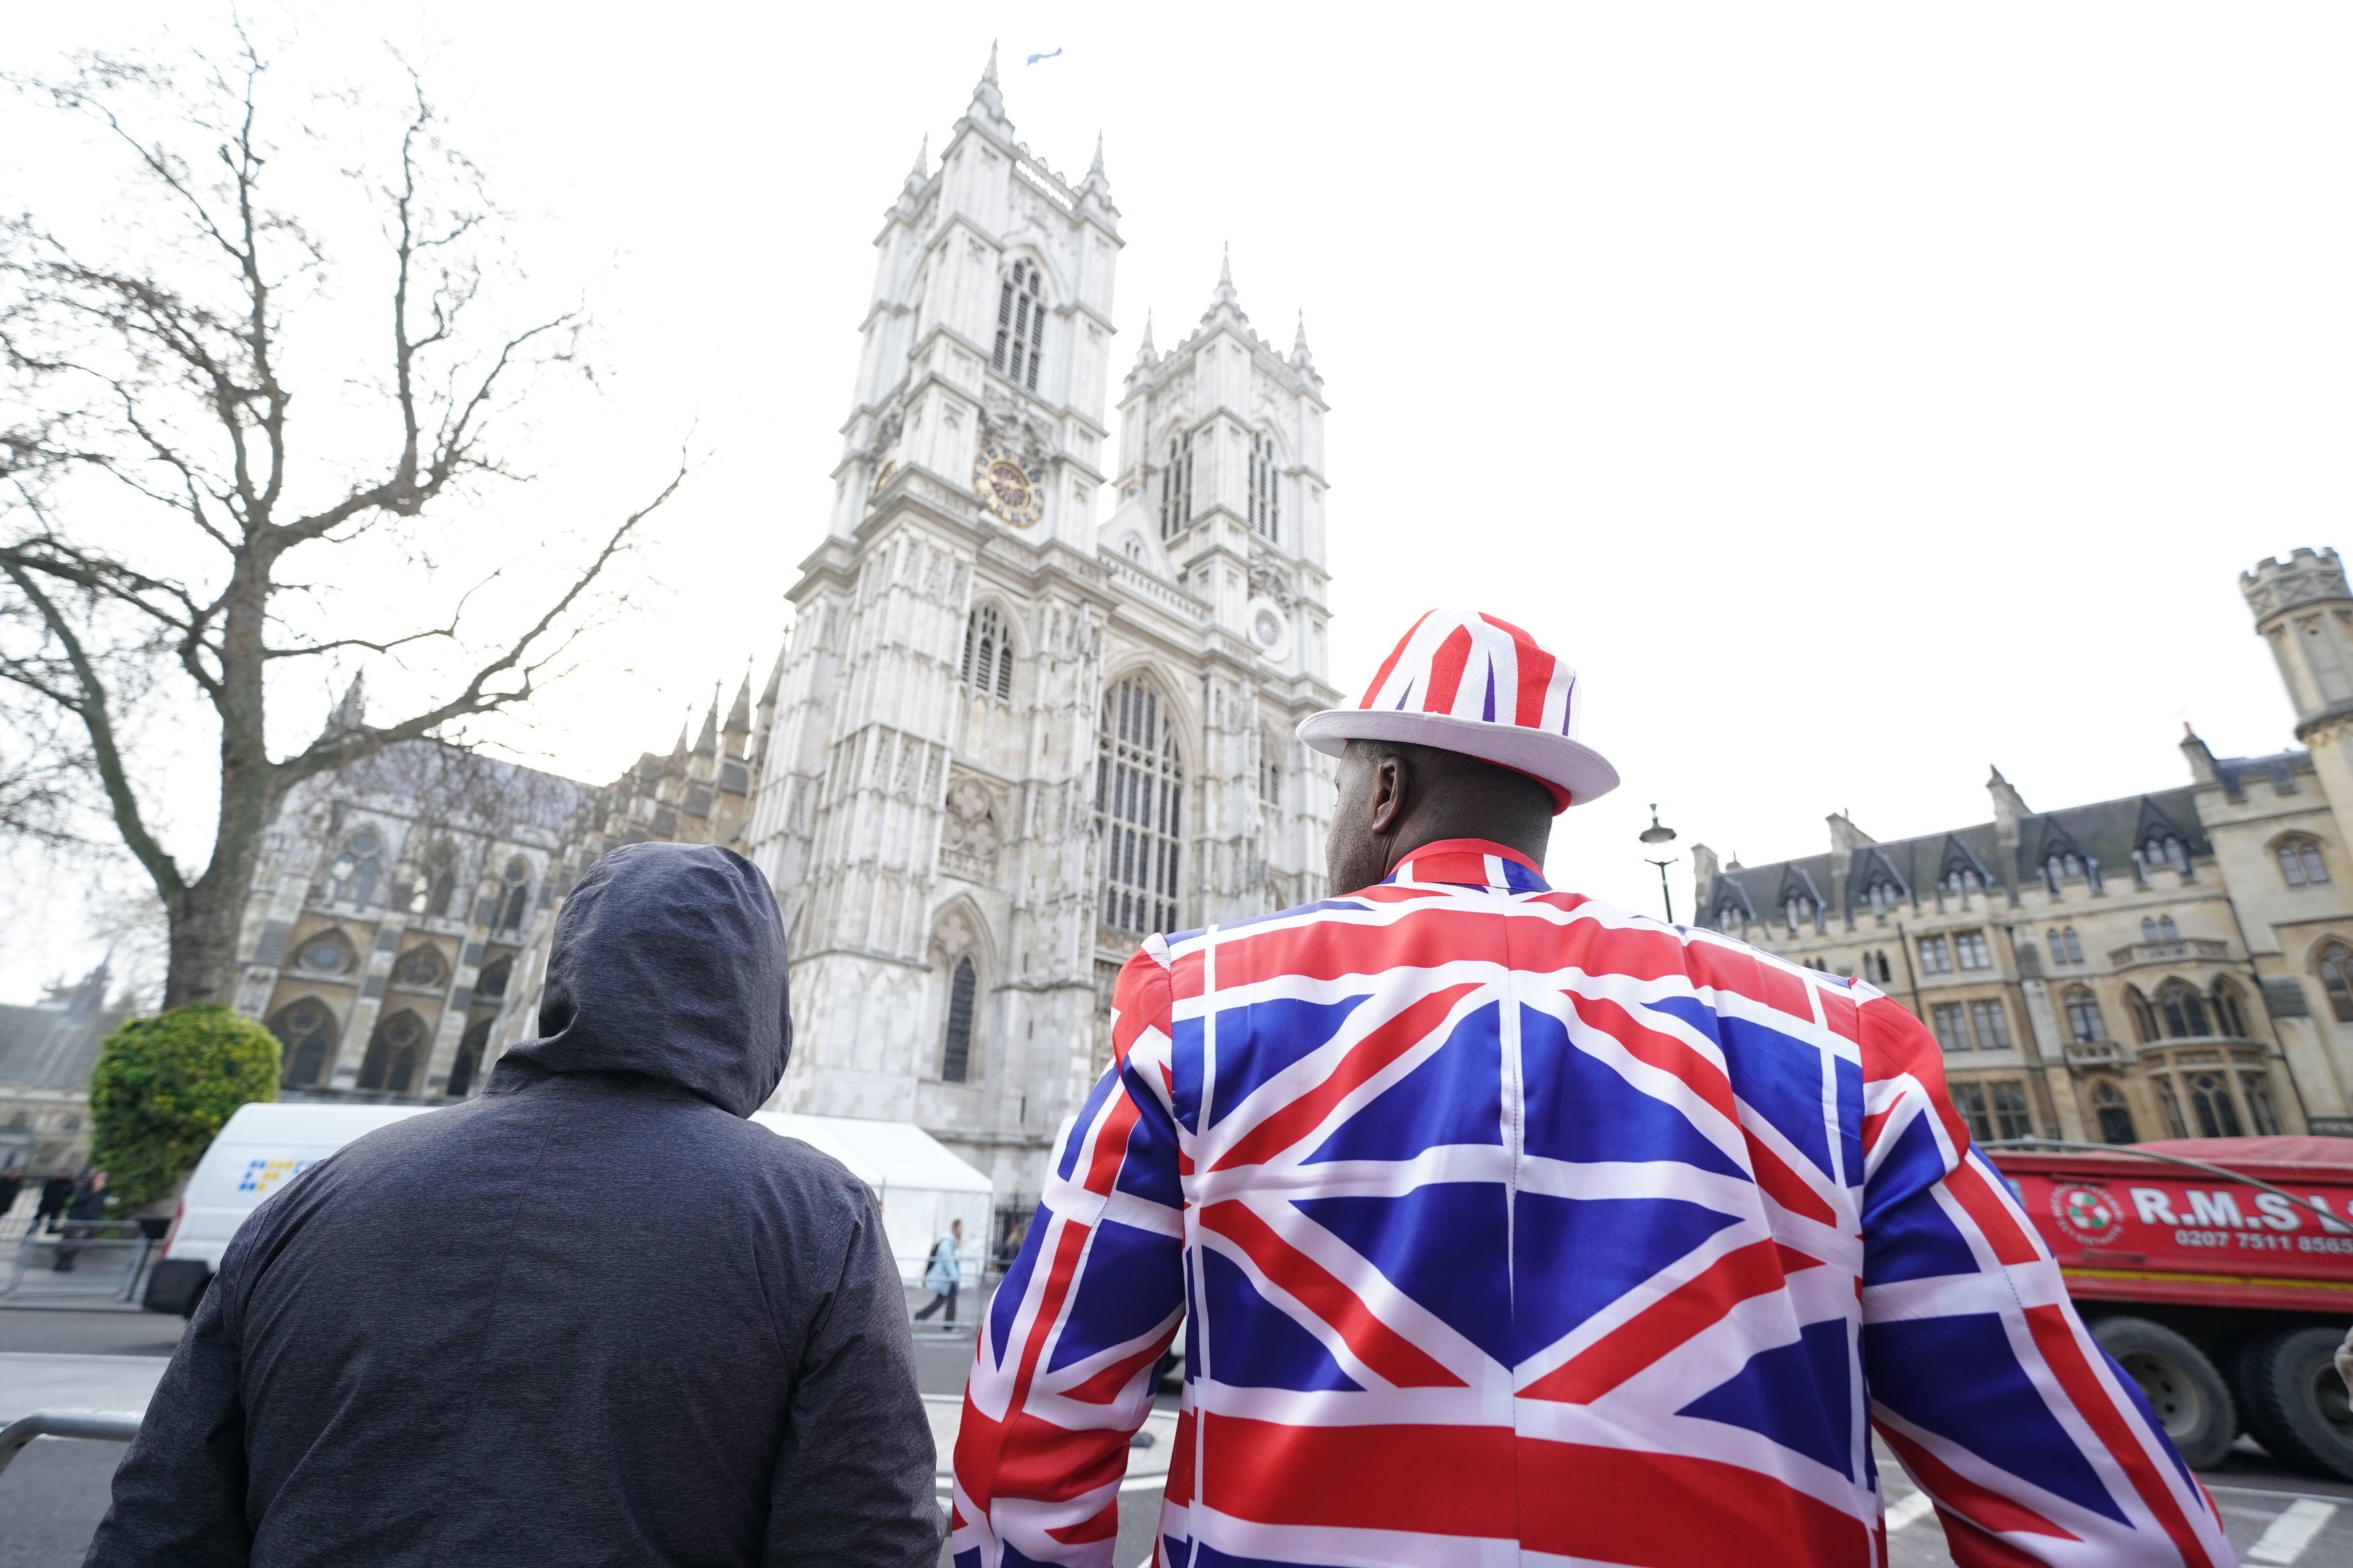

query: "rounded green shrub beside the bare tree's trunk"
left=89, top=1001, right=278, bottom=1213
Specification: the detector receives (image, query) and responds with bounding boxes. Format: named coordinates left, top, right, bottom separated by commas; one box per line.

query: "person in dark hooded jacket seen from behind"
left=85, top=844, right=941, bottom=1568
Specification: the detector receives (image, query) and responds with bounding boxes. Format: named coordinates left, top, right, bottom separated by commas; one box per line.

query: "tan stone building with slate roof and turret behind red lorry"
left=1692, top=550, right=2353, bottom=1143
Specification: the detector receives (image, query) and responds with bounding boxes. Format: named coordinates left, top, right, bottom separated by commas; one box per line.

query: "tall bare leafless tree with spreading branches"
left=0, top=33, right=685, bottom=1006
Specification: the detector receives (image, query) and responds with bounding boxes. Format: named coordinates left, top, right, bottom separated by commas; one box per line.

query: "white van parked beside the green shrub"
left=141, top=1102, right=431, bottom=1317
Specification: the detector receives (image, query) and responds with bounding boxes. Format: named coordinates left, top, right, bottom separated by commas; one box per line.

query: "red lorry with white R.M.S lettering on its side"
left=1986, top=1138, right=2353, bottom=1479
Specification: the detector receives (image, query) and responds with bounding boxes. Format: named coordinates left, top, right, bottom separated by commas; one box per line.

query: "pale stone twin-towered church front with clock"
left=746, top=52, right=1337, bottom=1204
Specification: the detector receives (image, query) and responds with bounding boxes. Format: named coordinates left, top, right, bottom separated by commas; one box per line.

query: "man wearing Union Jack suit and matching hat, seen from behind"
left=951, top=611, right=2231, bottom=1568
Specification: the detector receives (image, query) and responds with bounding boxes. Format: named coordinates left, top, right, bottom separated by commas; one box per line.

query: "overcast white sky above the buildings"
left=0, top=0, right=2353, bottom=997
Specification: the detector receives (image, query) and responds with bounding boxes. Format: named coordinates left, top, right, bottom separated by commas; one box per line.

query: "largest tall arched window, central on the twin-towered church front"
left=1094, top=679, right=1184, bottom=934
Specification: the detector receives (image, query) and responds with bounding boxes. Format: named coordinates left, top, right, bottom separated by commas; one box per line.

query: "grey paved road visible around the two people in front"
left=0, top=1303, right=2353, bottom=1568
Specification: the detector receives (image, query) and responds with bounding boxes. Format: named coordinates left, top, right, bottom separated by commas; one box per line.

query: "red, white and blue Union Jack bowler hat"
left=1299, top=609, right=1619, bottom=811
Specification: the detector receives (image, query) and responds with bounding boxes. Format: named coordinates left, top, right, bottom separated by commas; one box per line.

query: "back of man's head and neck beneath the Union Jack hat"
left=1325, top=741, right=1556, bottom=893
